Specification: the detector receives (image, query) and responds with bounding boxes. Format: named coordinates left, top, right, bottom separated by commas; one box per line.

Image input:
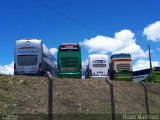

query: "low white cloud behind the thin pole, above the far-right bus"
left=133, top=59, right=160, bottom=71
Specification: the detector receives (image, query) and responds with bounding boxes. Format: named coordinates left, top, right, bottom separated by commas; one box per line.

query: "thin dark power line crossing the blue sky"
left=34, top=0, right=105, bottom=34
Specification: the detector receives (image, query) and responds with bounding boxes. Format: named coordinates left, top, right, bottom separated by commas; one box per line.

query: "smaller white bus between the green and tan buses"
left=84, top=54, right=109, bottom=79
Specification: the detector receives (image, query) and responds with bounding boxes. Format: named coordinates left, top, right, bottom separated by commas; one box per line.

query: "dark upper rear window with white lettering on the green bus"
left=60, top=44, right=79, bottom=52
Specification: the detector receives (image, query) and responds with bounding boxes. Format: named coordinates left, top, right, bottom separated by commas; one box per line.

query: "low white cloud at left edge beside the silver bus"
left=0, top=62, right=14, bottom=75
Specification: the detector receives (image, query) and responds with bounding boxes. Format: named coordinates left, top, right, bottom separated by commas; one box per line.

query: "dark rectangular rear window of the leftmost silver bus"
left=17, top=55, right=38, bottom=66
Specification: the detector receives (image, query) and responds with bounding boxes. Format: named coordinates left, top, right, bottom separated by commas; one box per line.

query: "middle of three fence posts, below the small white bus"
left=106, top=79, right=116, bottom=120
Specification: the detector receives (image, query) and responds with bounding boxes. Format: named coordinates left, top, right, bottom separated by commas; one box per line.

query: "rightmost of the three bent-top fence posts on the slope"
left=140, top=81, right=150, bottom=120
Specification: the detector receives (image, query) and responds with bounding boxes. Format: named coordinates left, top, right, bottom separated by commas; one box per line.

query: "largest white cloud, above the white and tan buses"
left=80, top=29, right=147, bottom=59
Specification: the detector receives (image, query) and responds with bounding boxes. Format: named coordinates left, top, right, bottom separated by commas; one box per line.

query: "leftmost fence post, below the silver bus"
left=47, top=71, right=53, bottom=120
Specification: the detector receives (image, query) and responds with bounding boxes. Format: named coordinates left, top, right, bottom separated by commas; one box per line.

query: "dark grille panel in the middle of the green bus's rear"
left=61, top=57, right=78, bottom=67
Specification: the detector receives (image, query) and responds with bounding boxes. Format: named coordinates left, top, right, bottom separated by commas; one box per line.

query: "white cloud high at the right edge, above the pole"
left=143, top=21, right=160, bottom=42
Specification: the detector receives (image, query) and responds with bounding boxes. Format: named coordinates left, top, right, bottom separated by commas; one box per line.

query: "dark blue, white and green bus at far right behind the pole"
left=133, top=67, right=160, bottom=83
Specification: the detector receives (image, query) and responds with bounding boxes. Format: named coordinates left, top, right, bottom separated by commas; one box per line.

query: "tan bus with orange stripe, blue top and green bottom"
left=109, top=53, right=133, bottom=81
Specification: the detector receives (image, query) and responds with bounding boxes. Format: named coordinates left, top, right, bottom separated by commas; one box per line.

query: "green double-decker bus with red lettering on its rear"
left=57, top=43, right=82, bottom=78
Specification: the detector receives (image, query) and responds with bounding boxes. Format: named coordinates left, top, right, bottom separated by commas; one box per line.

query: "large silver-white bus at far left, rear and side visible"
left=14, top=39, right=57, bottom=75
